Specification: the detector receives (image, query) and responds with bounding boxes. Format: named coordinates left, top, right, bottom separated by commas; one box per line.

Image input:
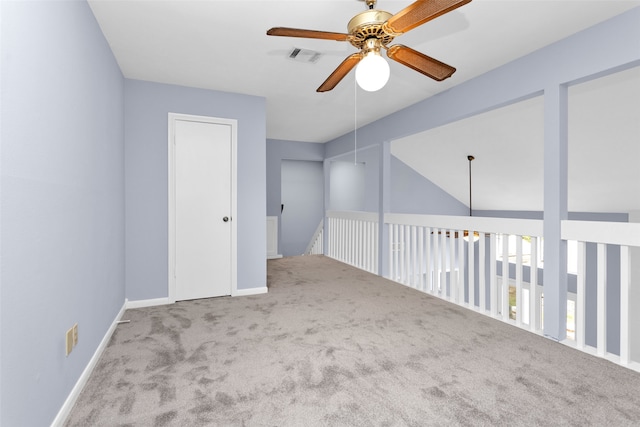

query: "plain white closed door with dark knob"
left=170, top=115, right=235, bottom=301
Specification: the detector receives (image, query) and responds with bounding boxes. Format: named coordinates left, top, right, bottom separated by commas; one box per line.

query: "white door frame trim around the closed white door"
left=168, top=113, right=238, bottom=303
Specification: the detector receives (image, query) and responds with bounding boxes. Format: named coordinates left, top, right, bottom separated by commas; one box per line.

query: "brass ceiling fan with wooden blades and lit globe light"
left=267, top=0, right=471, bottom=92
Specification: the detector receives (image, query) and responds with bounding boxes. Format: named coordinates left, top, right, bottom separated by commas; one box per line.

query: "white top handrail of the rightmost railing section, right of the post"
left=561, top=220, right=640, bottom=246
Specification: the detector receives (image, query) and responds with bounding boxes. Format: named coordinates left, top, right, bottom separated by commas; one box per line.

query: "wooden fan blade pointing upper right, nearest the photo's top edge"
left=382, top=0, right=471, bottom=36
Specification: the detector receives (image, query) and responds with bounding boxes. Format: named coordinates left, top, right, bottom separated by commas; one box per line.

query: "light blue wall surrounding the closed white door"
left=125, top=80, right=267, bottom=301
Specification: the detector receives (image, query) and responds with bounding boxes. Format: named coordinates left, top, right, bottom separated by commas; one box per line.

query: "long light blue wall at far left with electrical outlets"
left=0, top=1, right=125, bottom=427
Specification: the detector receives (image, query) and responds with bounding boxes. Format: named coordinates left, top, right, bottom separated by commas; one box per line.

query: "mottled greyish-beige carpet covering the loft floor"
left=67, top=256, right=640, bottom=426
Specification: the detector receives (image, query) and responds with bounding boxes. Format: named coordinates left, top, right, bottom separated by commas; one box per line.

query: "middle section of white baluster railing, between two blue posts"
left=385, top=214, right=542, bottom=333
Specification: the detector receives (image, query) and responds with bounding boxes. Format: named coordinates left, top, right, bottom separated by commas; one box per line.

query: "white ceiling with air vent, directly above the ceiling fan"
left=89, top=0, right=640, bottom=142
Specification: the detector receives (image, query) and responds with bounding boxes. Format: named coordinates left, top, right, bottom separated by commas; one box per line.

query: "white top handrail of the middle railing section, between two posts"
left=384, top=213, right=543, bottom=236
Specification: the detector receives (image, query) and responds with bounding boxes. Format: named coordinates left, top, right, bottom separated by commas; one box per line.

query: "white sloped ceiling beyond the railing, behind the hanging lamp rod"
left=391, top=67, right=640, bottom=213
